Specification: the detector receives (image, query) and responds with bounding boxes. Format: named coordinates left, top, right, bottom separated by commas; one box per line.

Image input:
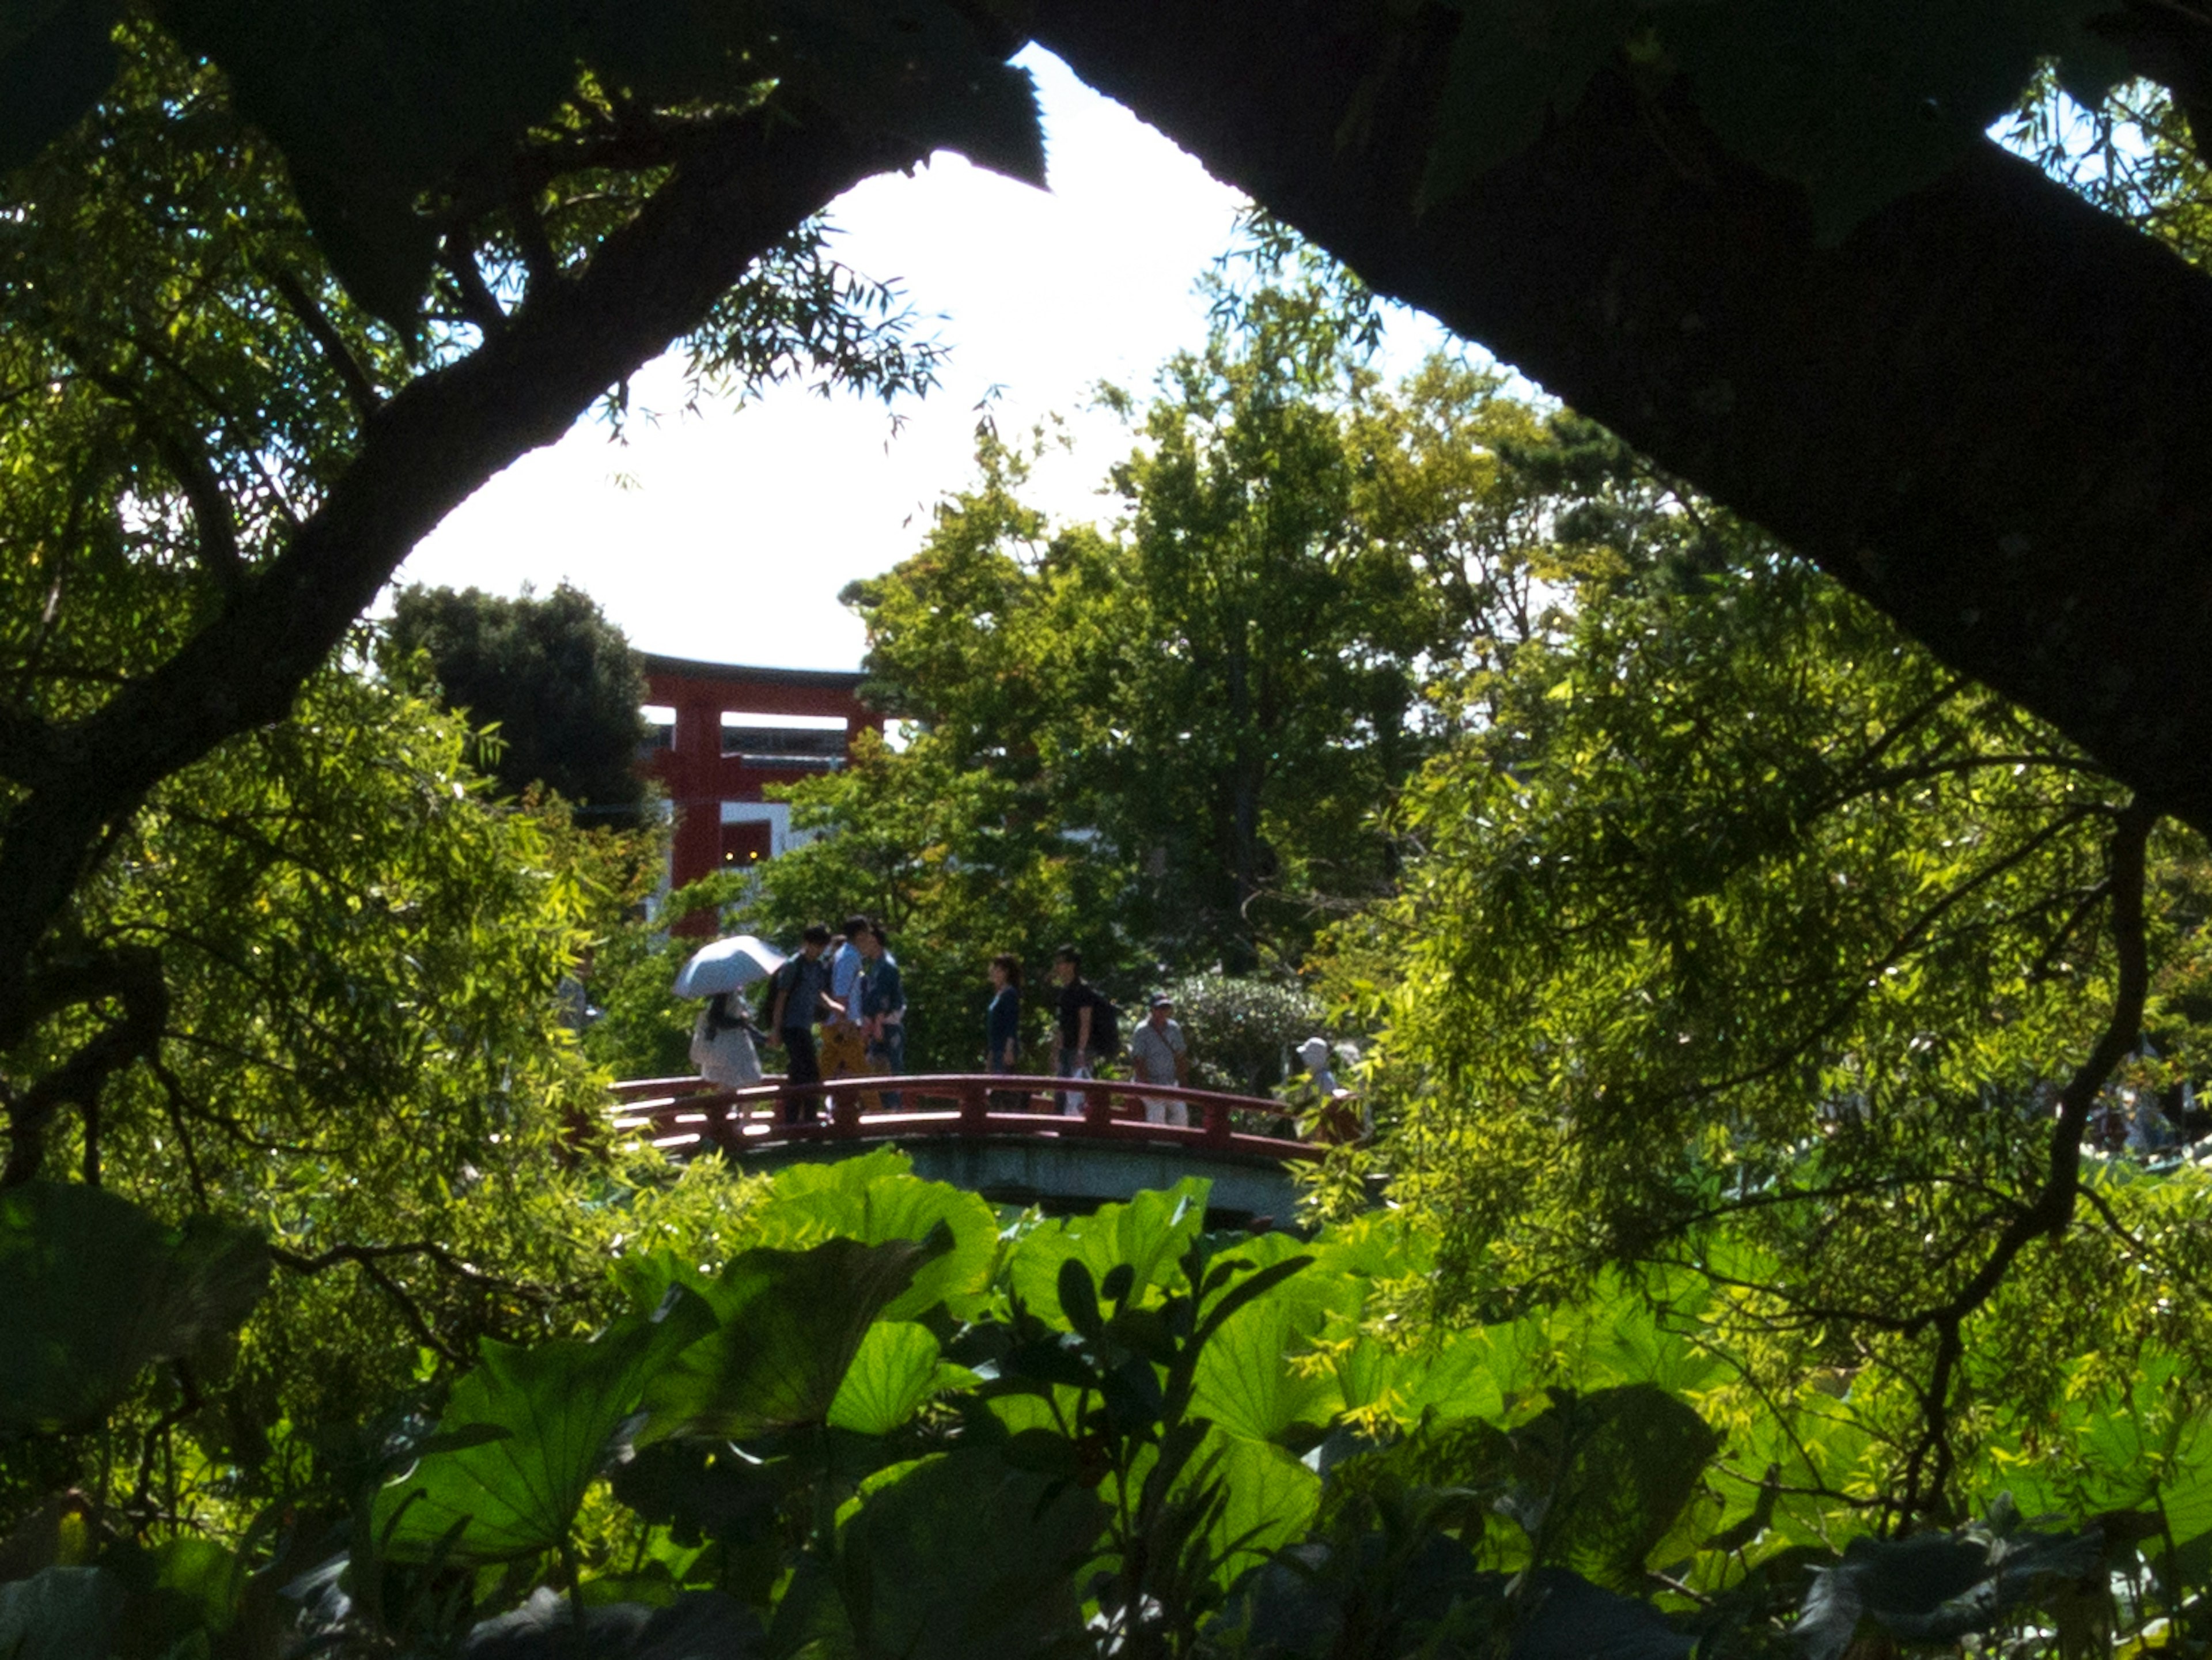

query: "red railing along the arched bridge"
left=613, top=1071, right=1323, bottom=1160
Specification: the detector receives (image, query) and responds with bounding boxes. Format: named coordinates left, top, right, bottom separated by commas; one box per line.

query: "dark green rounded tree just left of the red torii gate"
left=389, top=582, right=646, bottom=828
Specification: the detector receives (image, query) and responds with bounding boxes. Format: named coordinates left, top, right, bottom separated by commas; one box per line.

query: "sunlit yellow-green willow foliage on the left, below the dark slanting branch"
left=0, top=655, right=690, bottom=1540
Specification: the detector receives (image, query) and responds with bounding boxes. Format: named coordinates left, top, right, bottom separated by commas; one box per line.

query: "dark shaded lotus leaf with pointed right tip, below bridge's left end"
left=639, top=1222, right=953, bottom=1443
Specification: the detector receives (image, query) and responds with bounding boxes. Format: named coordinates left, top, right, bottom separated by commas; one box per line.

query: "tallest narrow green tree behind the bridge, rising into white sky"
left=1088, top=286, right=1433, bottom=971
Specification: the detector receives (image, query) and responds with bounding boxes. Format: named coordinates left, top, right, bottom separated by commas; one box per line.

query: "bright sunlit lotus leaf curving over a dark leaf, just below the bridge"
left=756, top=1151, right=998, bottom=1319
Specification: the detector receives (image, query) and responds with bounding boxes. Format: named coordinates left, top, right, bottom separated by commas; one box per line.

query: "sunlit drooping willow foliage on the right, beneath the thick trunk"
left=1338, top=534, right=2212, bottom=1521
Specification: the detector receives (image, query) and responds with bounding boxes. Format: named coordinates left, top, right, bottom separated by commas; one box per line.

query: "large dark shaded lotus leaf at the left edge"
left=0, top=1182, right=270, bottom=1430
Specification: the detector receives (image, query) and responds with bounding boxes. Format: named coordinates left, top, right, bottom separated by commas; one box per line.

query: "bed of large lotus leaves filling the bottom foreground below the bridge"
left=0, top=1153, right=2212, bottom=1660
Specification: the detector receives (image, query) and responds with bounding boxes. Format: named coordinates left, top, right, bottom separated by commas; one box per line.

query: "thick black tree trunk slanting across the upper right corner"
left=1033, top=0, right=2212, bottom=832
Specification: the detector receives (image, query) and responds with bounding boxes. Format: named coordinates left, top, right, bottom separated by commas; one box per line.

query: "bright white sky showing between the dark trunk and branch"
left=398, top=51, right=1445, bottom=668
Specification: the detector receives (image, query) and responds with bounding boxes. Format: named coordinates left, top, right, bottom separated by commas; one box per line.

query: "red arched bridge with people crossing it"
left=615, top=1073, right=1323, bottom=1226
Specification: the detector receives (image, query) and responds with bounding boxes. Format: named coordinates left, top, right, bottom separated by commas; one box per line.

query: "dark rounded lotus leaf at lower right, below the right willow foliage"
left=1502, top=1383, right=1721, bottom=1587
